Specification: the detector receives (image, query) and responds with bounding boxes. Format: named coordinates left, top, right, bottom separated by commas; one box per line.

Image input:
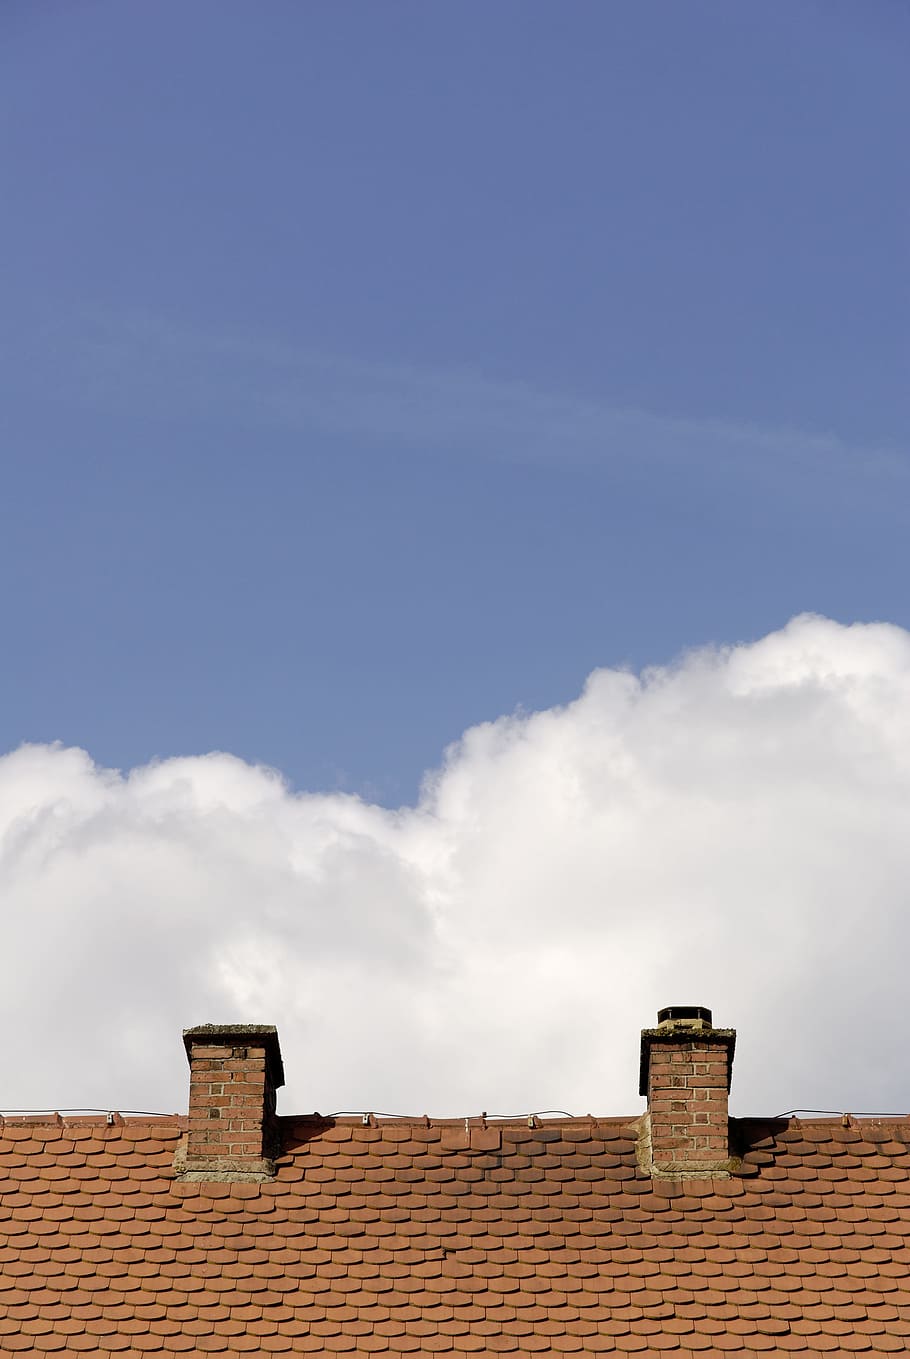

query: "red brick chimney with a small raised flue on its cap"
left=638, top=1006, right=736, bottom=1178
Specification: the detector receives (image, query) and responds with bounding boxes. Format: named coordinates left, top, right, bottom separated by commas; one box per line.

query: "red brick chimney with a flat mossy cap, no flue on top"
left=175, top=1023, right=284, bottom=1181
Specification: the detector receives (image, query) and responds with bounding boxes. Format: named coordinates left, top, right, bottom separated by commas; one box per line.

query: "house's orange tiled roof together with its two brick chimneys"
left=0, top=1007, right=910, bottom=1359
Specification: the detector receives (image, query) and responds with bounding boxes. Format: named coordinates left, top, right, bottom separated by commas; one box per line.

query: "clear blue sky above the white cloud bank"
left=0, top=0, right=910, bottom=806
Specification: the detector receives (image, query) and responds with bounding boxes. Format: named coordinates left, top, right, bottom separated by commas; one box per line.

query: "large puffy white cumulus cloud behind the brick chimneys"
left=0, top=617, right=910, bottom=1113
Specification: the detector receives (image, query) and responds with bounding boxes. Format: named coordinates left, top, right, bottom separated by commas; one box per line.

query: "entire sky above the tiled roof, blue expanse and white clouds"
left=0, top=0, right=910, bottom=1113
